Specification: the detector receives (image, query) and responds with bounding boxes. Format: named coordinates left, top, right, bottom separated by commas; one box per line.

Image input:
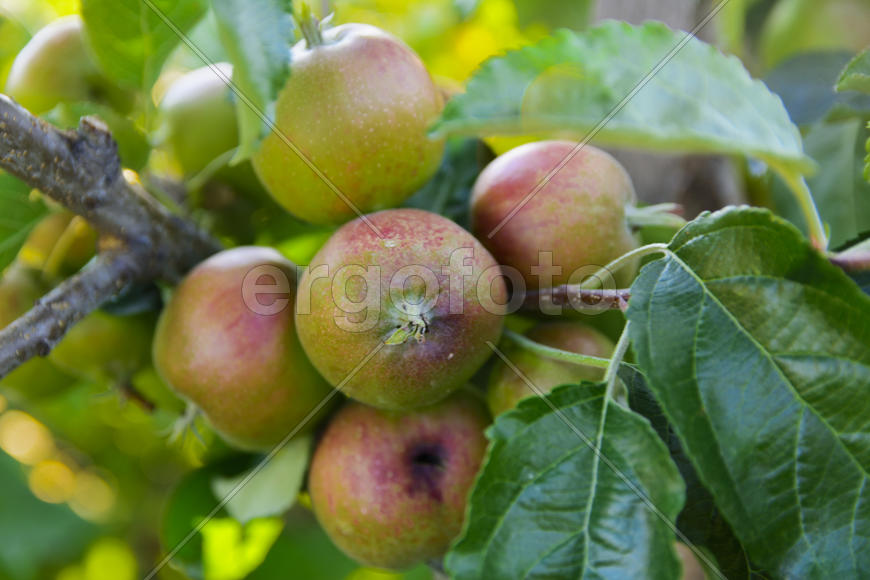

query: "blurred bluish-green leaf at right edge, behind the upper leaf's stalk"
left=771, top=119, right=870, bottom=248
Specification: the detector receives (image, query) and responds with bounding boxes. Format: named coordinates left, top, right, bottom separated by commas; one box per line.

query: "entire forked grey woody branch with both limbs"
left=0, top=95, right=220, bottom=377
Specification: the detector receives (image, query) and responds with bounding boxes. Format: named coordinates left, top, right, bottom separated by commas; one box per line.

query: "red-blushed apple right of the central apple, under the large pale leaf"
left=471, top=141, right=638, bottom=289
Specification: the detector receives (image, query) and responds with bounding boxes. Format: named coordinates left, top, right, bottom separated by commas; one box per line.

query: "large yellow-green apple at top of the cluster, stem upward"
left=252, top=24, right=444, bottom=224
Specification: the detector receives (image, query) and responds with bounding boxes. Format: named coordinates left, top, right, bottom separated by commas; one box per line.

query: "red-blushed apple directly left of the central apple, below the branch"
left=153, top=246, right=331, bottom=450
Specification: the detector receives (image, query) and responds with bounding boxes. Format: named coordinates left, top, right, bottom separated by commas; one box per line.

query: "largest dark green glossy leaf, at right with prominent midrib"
left=627, top=208, right=870, bottom=578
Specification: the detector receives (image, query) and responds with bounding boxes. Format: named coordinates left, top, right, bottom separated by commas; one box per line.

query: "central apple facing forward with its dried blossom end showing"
left=296, top=209, right=507, bottom=410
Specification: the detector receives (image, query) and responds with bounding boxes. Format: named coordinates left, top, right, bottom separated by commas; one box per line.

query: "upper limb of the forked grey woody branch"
left=0, top=95, right=219, bottom=281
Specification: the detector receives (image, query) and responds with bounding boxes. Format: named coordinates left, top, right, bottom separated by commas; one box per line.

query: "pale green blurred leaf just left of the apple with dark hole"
left=211, top=437, right=311, bottom=524
